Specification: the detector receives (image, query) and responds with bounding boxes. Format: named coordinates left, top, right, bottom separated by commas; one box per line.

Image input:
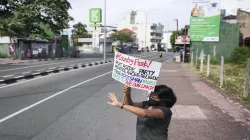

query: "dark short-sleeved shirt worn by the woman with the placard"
left=136, top=102, right=172, bottom=140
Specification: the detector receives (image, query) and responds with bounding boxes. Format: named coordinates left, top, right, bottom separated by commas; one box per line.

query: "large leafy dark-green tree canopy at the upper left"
left=0, top=0, right=73, bottom=37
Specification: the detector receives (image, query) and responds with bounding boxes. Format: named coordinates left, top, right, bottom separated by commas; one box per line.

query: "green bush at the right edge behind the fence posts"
left=230, top=46, right=250, bottom=67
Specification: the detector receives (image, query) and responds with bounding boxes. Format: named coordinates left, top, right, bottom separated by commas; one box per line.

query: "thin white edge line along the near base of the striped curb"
left=0, top=63, right=111, bottom=89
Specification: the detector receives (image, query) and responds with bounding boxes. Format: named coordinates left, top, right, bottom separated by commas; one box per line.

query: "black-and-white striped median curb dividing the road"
left=0, top=59, right=114, bottom=83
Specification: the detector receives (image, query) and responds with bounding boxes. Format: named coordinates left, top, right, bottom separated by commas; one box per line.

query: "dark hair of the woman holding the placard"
left=154, top=85, right=177, bottom=108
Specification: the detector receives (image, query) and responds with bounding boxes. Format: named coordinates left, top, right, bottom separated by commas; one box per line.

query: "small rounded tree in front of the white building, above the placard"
left=109, top=31, right=133, bottom=46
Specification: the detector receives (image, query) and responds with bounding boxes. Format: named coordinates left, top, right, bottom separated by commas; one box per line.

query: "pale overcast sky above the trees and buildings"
left=67, top=0, right=250, bottom=34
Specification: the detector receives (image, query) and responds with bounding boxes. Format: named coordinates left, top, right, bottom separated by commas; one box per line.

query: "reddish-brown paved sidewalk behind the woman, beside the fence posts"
left=158, top=61, right=250, bottom=140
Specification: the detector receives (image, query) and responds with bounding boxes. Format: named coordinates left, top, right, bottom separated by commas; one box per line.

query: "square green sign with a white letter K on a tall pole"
left=89, top=8, right=102, bottom=23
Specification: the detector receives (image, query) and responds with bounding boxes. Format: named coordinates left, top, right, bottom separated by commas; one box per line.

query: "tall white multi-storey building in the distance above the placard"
left=117, top=11, right=164, bottom=50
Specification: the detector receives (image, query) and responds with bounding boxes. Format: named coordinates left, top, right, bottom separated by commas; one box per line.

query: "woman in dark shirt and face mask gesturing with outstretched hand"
left=108, top=85, right=177, bottom=140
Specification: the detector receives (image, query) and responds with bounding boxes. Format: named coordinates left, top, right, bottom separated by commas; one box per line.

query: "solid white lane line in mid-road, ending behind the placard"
left=0, top=71, right=112, bottom=123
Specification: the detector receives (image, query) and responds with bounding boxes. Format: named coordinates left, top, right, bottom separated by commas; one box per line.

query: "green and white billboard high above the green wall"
left=190, top=0, right=221, bottom=42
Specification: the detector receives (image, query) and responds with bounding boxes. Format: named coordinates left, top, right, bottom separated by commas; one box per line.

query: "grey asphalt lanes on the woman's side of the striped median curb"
left=0, top=52, right=172, bottom=140
